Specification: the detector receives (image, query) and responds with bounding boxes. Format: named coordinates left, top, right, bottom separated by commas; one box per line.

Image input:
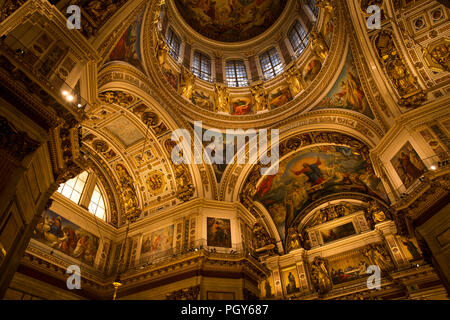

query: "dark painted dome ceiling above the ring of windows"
left=175, top=0, right=287, bottom=42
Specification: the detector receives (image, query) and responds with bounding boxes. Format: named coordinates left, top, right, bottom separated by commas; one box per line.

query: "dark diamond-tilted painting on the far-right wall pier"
left=391, top=142, right=426, bottom=189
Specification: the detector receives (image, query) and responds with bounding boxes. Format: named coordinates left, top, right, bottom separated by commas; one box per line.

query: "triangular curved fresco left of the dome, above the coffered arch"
left=109, top=12, right=144, bottom=71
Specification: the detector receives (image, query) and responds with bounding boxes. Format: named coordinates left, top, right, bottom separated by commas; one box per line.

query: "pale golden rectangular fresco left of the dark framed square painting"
left=141, top=225, right=174, bottom=256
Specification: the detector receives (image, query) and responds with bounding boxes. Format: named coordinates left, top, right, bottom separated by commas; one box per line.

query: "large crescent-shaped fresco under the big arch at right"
left=255, top=145, right=388, bottom=240
